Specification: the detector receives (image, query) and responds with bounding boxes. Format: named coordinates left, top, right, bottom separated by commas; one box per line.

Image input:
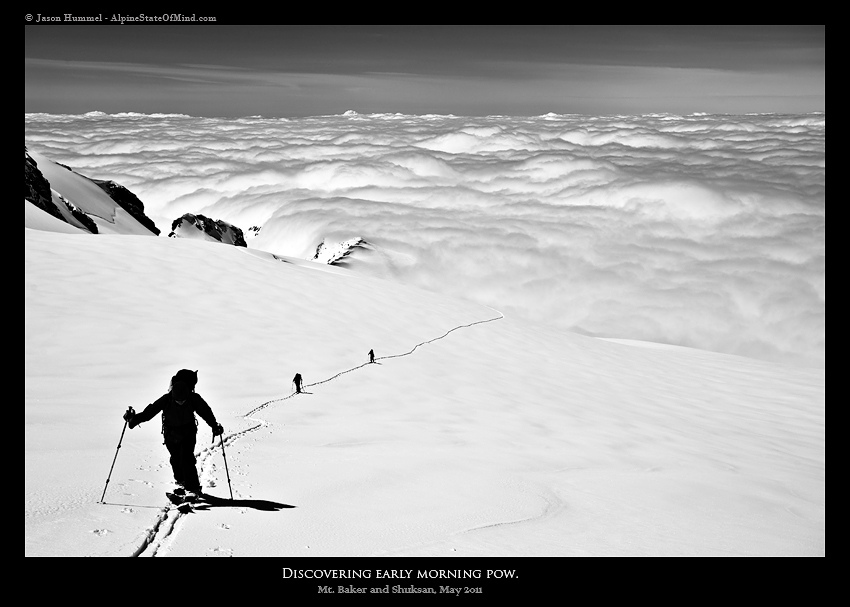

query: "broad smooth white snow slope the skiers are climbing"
left=24, top=209, right=825, bottom=557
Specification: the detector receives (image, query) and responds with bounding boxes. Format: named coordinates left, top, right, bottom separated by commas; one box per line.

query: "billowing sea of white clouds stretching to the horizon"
left=25, top=112, right=826, bottom=367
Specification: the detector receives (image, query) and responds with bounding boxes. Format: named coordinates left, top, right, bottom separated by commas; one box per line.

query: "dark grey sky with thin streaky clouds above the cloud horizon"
left=25, top=25, right=826, bottom=117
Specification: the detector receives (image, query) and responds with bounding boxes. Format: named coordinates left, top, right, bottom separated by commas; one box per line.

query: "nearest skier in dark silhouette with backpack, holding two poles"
left=124, top=369, right=224, bottom=501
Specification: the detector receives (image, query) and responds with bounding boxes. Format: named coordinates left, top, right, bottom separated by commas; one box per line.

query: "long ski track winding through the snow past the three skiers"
left=131, top=308, right=500, bottom=557
